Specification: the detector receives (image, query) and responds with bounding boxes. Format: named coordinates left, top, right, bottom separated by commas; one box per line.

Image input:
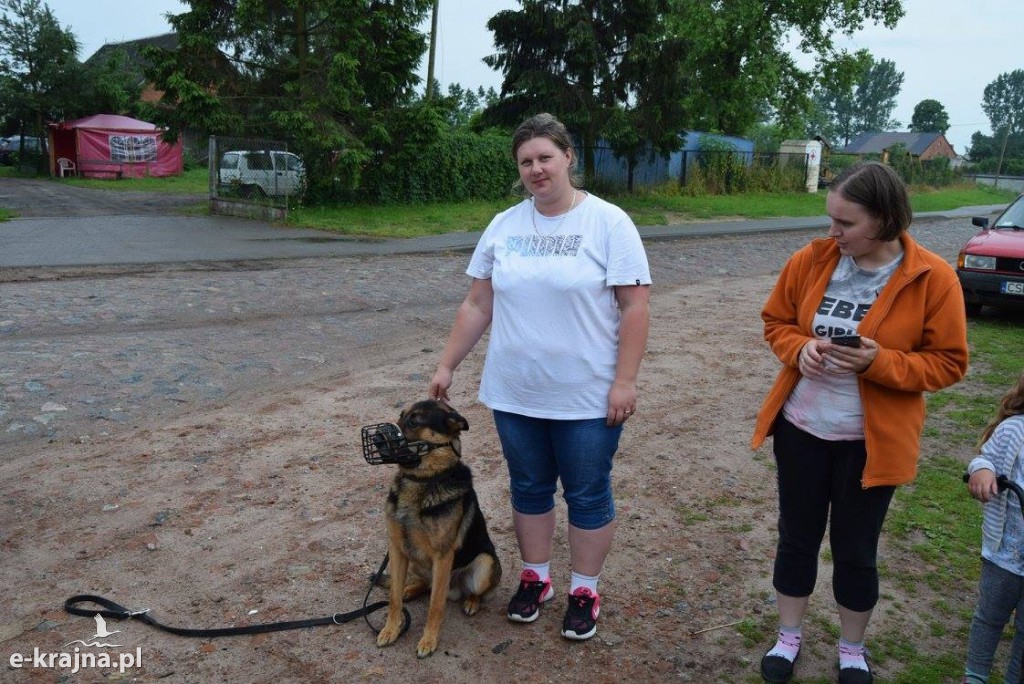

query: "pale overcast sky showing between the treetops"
left=44, top=0, right=1024, bottom=154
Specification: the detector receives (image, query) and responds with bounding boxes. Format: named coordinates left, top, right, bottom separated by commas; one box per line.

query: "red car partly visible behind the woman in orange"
left=956, top=195, right=1024, bottom=315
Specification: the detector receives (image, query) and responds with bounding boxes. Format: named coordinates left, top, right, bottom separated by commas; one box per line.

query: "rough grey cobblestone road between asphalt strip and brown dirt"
left=0, top=219, right=987, bottom=452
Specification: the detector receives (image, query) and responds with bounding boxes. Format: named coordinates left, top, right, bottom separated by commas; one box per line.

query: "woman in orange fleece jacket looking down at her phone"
left=752, top=162, right=968, bottom=684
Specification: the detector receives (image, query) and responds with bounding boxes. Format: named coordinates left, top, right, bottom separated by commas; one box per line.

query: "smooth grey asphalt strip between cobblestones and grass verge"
left=0, top=178, right=997, bottom=268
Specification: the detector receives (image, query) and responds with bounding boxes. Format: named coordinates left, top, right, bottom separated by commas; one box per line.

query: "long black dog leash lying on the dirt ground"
left=63, top=555, right=412, bottom=639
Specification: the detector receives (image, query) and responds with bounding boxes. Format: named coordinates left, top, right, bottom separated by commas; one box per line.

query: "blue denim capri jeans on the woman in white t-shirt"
left=494, top=411, right=623, bottom=529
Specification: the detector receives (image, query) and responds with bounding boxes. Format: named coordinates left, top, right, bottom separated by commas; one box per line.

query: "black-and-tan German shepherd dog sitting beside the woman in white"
left=377, top=399, right=502, bottom=658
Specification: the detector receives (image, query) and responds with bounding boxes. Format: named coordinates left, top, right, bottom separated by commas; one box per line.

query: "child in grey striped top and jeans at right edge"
left=961, top=372, right=1024, bottom=684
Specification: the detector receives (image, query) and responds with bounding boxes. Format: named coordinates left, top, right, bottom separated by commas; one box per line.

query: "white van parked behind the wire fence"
left=218, top=149, right=306, bottom=197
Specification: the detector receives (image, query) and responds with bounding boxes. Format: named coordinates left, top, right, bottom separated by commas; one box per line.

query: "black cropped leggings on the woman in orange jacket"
left=772, top=415, right=896, bottom=612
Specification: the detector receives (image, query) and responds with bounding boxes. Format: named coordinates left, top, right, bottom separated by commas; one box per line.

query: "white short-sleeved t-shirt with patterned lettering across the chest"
left=466, top=189, right=651, bottom=420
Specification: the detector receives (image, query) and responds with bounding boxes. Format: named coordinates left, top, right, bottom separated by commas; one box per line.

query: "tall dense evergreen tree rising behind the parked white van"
left=147, top=0, right=432, bottom=197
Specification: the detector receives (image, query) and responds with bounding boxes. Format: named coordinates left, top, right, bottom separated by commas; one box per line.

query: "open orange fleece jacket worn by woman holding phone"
left=751, top=232, right=968, bottom=488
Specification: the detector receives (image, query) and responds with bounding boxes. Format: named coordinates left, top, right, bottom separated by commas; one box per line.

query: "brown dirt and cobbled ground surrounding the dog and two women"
left=0, top=205, right=1015, bottom=683
